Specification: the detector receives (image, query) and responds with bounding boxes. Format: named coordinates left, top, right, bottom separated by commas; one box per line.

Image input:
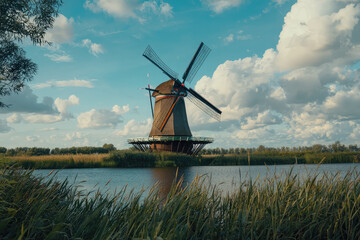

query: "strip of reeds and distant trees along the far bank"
left=0, top=142, right=360, bottom=169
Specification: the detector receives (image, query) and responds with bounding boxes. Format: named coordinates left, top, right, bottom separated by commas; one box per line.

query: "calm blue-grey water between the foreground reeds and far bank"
left=34, top=163, right=360, bottom=197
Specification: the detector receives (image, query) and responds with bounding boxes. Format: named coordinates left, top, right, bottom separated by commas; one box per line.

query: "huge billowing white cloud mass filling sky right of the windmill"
left=191, top=0, right=360, bottom=145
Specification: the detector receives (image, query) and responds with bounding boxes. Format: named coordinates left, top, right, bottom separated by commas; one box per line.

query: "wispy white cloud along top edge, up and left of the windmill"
left=84, top=0, right=173, bottom=22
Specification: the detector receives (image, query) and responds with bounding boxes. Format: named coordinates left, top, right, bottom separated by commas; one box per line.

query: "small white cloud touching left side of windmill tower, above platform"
left=115, top=118, right=152, bottom=137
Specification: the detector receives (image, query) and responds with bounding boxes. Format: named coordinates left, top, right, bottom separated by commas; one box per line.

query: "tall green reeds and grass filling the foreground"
left=0, top=167, right=360, bottom=239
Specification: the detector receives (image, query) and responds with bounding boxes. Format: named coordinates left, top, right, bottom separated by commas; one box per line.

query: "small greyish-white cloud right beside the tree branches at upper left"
left=45, top=14, right=74, bottom=44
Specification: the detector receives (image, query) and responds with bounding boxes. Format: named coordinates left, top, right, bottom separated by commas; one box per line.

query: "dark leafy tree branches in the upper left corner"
left=0, top=0, right=62, bottom=107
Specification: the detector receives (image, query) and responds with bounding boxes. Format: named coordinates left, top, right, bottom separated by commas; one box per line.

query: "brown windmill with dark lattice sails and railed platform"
left=128, top=42, right=221, bottom=154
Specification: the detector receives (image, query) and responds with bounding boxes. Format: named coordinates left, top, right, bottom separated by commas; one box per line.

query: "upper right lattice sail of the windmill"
left=182, top=42, right=211, bottom=83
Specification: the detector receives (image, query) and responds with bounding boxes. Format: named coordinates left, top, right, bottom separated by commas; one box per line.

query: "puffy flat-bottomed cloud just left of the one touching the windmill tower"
left=77, top=105, right=129, bottom=129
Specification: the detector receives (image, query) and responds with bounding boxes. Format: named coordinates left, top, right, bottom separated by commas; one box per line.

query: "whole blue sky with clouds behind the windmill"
left=0, top=0, right=360, bottom=149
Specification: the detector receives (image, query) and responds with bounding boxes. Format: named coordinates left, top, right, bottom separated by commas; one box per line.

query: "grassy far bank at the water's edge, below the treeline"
left=0, top=150, right=360, bottom=169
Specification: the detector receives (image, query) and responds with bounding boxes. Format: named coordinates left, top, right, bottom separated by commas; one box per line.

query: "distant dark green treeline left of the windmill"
left=0, top=144, right=116, bottom=156
